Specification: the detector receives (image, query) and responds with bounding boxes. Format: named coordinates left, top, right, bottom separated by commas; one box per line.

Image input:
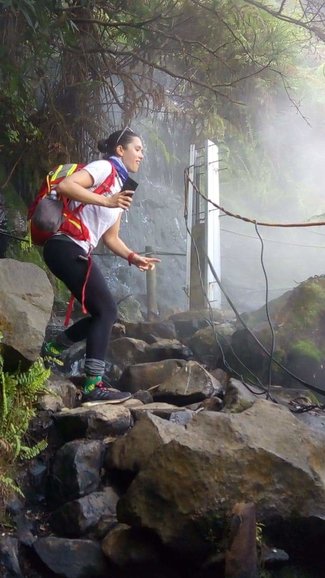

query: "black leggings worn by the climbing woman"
left=43, top=237, right=117, bottom=361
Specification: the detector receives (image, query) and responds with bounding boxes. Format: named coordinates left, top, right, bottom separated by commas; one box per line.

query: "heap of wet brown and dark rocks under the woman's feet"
left=0, top=276, right=325, bottom=578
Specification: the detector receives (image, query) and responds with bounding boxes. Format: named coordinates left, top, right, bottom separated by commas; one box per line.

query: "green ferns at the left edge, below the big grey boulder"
left=0, top=336, right=50, bottom=512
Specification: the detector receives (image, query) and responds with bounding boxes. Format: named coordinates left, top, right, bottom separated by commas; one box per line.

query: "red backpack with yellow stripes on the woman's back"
left=27, top=163, right=116, bottom=245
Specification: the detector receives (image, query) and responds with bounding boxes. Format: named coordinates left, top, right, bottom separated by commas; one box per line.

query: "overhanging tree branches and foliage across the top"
left=0, top=0, right=321, bottom=187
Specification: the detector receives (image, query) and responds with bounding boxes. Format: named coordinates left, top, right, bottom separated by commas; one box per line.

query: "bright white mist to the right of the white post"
left=220, top=83, right=325, bottom=311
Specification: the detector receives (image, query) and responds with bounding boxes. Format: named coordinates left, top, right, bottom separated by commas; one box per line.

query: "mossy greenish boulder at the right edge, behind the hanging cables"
left=226, top=276, right=325, bottom=394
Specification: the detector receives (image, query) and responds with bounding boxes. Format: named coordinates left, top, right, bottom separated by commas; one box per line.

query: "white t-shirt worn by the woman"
left=61, top=160, right=123, bottom=253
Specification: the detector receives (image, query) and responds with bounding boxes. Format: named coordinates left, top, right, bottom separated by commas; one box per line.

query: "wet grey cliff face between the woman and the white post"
left=97, top=127, right=190, bottom=314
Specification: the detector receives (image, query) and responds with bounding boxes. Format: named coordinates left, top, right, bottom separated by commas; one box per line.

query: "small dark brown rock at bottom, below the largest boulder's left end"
left=102, top=524, right=159, bottom=566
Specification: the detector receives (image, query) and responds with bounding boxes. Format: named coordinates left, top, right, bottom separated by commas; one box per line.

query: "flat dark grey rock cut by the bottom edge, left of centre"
left=34, top=536, right=109, bottom=578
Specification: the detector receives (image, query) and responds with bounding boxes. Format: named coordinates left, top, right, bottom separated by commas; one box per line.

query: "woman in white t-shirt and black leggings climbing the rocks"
left=43, top=128, right=159, bottom=405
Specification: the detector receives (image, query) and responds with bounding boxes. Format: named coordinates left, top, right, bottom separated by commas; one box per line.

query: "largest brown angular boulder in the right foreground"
left=113, top=400, right=325, bottom=556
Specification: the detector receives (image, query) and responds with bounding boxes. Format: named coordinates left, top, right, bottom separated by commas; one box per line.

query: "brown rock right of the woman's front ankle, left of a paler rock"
left=118, top=359, right=186, bottom=393
